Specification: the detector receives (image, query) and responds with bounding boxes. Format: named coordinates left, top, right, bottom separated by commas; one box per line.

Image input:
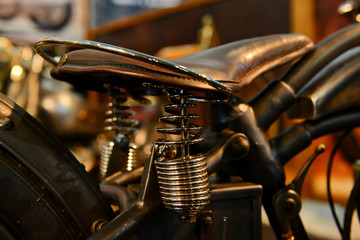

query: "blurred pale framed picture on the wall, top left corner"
left=0, top=0, right=88, bottom=42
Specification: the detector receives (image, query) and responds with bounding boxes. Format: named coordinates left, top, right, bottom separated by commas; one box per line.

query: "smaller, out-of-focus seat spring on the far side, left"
left=100, top=88, right=141, bottom=178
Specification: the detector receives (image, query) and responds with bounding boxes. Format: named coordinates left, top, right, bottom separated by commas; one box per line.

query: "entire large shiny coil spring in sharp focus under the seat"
left=155, top=90, right=210, bottom=222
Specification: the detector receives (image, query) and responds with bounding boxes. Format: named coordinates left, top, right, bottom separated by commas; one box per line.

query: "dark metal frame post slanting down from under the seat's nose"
left=215, top=103, right=285, bottom=192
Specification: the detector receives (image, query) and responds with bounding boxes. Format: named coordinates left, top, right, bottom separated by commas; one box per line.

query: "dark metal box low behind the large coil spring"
left=134, top=182, right=262, bottom=240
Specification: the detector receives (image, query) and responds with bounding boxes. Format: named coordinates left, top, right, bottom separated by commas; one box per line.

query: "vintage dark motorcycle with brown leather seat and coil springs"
left=0, top=20, right=360, bottom=239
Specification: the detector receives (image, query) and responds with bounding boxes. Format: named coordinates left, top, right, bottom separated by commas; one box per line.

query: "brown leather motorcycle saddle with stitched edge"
left=35, top=34, right=314, bottom=100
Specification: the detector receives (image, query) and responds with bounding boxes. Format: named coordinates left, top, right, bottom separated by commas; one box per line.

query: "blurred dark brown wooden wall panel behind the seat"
left=90, top=0, right=289, bottom=54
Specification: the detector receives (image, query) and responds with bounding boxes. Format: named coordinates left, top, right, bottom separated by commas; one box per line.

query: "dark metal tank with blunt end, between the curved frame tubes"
left=288, top=48, right=360, bottom=119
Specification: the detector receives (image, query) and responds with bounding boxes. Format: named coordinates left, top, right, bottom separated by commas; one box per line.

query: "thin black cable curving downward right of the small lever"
left=326, top=129, right=352, bottom=235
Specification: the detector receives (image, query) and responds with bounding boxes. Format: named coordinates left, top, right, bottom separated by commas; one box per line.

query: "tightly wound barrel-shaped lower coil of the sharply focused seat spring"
left=156, top=156, right=210, bottom=222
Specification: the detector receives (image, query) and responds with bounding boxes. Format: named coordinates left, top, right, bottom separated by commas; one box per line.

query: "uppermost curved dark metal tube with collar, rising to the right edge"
left=249, top=24, right=360, bottom=131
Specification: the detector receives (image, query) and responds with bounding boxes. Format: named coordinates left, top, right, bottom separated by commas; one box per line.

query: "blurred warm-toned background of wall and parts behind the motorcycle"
left=0, top=0, right=360, bottom=238
